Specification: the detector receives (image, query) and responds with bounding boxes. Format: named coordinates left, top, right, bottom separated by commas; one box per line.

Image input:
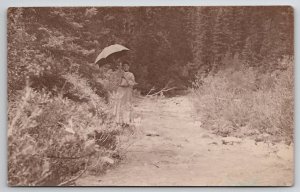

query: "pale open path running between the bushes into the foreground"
left=77, top=97, right=293, bottom=186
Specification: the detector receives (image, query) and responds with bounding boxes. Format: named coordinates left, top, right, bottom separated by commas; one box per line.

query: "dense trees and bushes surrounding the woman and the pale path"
left=7, top=6, right=294, bottom=185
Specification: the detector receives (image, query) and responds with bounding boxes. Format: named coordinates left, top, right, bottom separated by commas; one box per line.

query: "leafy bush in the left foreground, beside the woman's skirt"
left=8, top=74, right=126, bottom=185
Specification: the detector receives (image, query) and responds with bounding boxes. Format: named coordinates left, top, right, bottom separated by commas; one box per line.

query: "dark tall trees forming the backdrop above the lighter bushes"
left=8, top=6, right=294, bottom=97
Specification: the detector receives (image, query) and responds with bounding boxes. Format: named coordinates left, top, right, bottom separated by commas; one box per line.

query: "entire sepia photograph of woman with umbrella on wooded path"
left=7, top=6, right=295, bottom=187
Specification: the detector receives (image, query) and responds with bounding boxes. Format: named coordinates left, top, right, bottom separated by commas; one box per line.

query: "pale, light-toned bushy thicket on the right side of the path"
left=193, top=58, right=294, bottom=141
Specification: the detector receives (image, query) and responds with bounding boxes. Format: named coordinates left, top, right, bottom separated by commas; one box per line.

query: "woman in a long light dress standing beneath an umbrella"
left=114, top=62, right=136, bottom=124
